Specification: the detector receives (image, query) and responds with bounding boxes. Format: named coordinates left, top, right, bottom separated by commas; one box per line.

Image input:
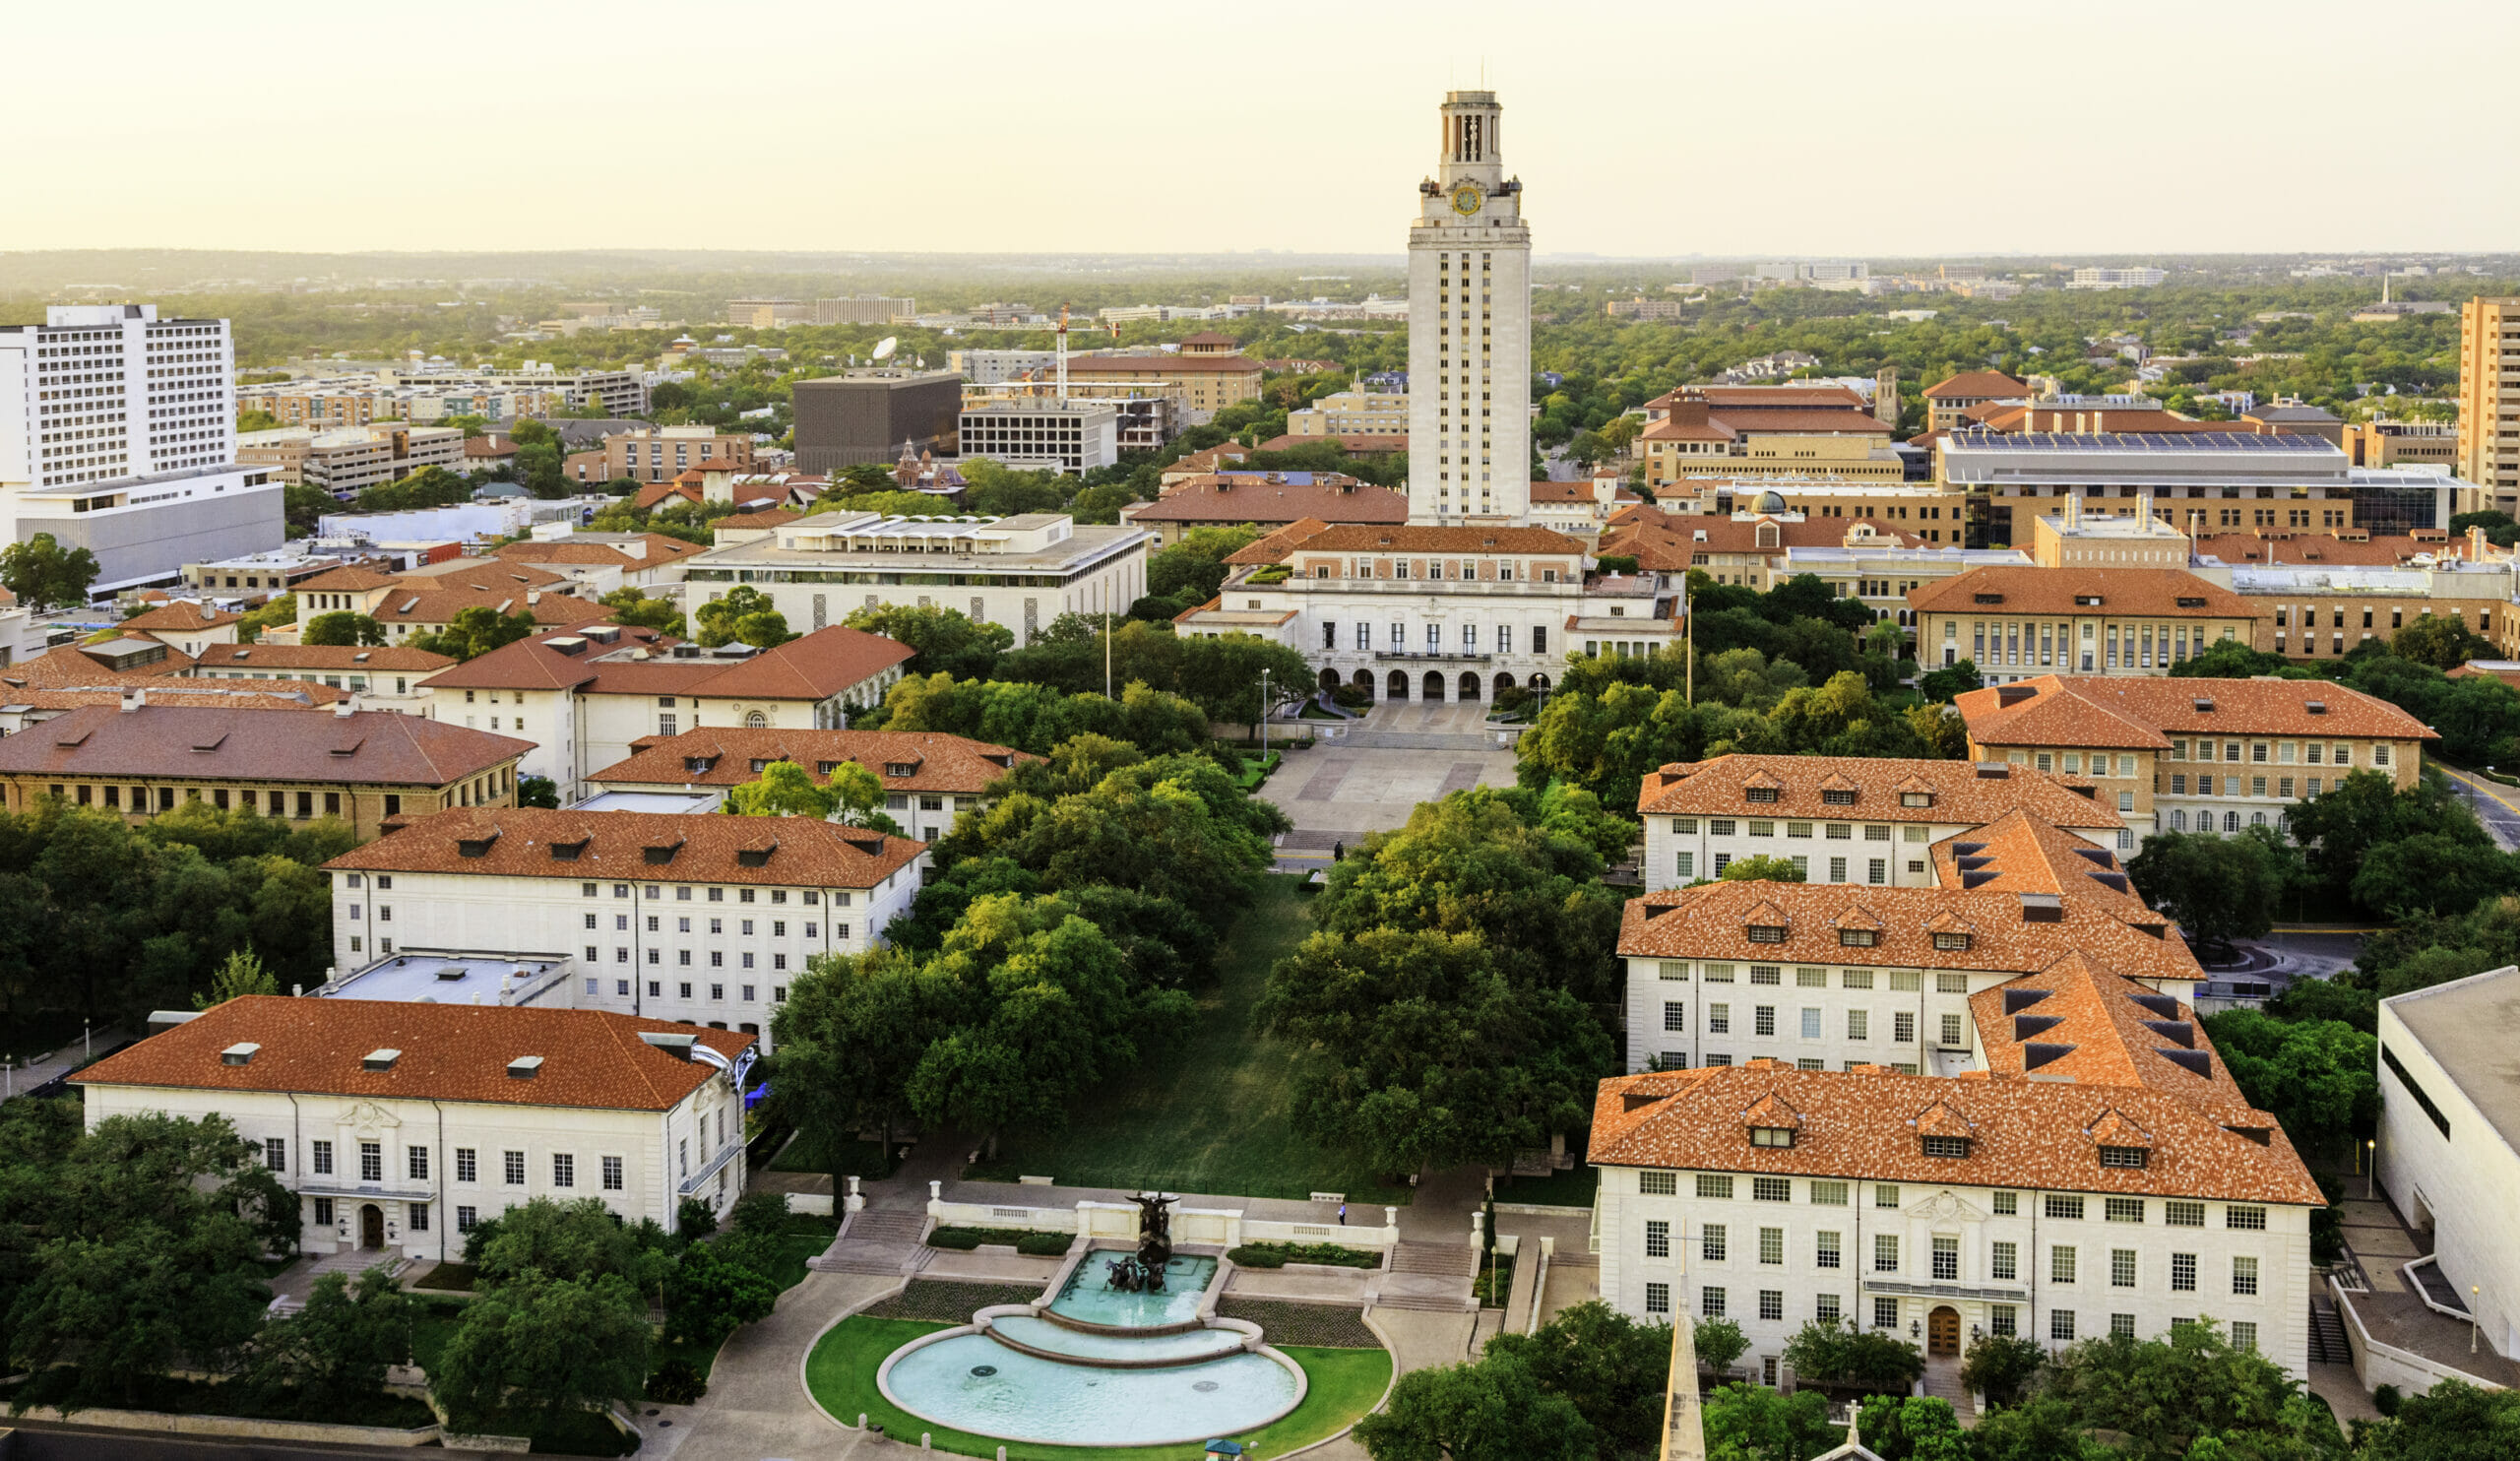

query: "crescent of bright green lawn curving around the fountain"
left=804, top=1315, right=1391, bottom=1461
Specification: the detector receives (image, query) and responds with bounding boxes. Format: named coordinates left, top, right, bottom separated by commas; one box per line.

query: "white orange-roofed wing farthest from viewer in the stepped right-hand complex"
left=1635, top=756, right=2134, bottom=889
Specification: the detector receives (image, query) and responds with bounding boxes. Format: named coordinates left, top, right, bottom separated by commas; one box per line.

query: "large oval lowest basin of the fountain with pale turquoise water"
left=877, top=1329, right=1305, bottom=1446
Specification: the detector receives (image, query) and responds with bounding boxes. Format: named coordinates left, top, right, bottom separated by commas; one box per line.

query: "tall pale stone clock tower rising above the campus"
left=1409, top=91, right=1532, bottom=527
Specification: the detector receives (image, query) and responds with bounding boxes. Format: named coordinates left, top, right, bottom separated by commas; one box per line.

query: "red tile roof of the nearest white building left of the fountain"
left=78, top=995, right=756, bottom=1111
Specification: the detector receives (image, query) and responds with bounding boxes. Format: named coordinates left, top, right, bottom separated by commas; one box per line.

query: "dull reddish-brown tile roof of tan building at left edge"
left=0, top=705, right=535, bottom=786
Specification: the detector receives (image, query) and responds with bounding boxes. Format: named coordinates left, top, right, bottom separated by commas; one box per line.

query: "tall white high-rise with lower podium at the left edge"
left=0, top=305, right=284, bottom=592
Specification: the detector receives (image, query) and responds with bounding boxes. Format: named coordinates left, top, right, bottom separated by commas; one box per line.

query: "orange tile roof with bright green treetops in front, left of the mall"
left=587, top=728, right=1040, bottom=796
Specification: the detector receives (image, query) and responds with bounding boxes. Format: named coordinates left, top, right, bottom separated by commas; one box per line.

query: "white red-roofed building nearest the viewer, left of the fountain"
left=78, top=995, right=753, bottom=1259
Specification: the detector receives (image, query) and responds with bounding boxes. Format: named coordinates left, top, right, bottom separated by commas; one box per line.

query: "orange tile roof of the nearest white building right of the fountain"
left=1585, top=1060, right=2326, bottom=1207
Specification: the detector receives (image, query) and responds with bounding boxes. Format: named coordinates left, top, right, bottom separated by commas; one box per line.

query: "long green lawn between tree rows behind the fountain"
left=973, top=876, right=1409, bottom=1198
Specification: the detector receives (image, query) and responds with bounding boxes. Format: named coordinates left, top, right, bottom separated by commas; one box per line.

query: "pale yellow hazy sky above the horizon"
left=0, top=0, right=2520, bottom=257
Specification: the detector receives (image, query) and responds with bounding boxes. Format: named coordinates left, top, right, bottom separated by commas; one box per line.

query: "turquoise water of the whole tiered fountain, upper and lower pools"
left=877, top=1249, right=1303, bottom=1446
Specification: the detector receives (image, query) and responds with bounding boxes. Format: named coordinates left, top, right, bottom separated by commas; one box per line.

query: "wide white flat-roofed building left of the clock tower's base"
left=683, top=511, right=1154, bottom=648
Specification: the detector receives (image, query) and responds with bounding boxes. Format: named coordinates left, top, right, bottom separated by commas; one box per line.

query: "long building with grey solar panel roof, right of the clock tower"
left=1935, top=431, right=2480, bottom=546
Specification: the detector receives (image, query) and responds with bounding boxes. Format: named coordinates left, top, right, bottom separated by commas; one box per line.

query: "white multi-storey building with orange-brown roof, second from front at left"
left=325, top=806, right=927, bottom=1038
